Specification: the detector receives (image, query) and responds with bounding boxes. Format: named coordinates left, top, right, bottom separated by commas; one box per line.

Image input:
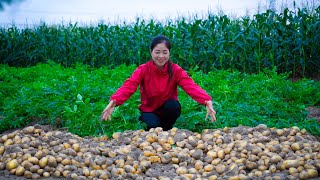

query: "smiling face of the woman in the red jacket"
left=151, top=42, right=170, bottom=69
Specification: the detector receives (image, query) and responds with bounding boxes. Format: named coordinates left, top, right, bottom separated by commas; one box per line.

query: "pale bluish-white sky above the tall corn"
left=0, top=0, right=312, bottom=25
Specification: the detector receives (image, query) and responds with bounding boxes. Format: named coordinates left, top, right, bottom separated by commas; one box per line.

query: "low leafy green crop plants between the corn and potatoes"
left=0, top=61, right=320, bottom=136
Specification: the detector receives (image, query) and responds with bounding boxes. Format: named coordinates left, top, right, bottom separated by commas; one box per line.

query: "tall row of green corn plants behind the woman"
left=0, top=7, right=320, bottom=76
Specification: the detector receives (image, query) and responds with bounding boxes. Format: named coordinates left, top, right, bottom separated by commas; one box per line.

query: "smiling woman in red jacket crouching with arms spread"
left=101, top=35, right=216, bottom=130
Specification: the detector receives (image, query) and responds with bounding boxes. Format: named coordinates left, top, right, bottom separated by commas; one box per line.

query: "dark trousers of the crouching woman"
left=140, top=99, right=181, bottom=131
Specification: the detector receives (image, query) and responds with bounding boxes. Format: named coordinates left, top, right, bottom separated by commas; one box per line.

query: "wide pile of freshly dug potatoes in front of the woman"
left=0, top=124, right=320, bottom=180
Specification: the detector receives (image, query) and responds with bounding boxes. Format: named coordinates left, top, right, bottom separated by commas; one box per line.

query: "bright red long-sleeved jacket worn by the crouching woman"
left=110, top=60, right=211, bottom=112
